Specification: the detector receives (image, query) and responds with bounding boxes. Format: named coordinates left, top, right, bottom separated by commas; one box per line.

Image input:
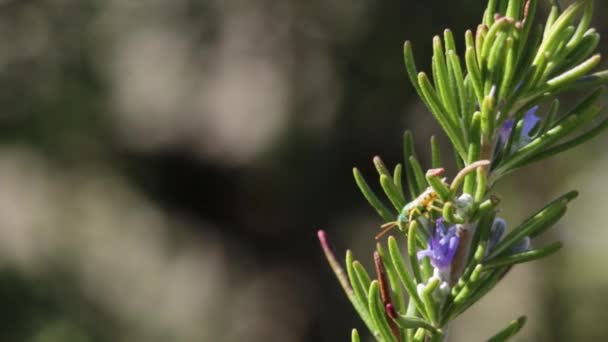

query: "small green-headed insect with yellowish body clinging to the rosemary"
left=376, top=168, right=444, bottom=239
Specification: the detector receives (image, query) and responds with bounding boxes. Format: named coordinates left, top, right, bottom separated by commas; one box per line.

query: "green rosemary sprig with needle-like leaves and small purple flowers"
left=318, top=0, right=608, bottom=342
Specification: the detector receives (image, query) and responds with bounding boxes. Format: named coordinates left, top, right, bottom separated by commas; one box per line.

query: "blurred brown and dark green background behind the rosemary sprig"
left=0, top=0, right=608, bottom=342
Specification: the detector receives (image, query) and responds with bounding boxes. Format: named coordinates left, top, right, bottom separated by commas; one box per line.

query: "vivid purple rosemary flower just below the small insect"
left=418, top=218, right=459, bottom=271
